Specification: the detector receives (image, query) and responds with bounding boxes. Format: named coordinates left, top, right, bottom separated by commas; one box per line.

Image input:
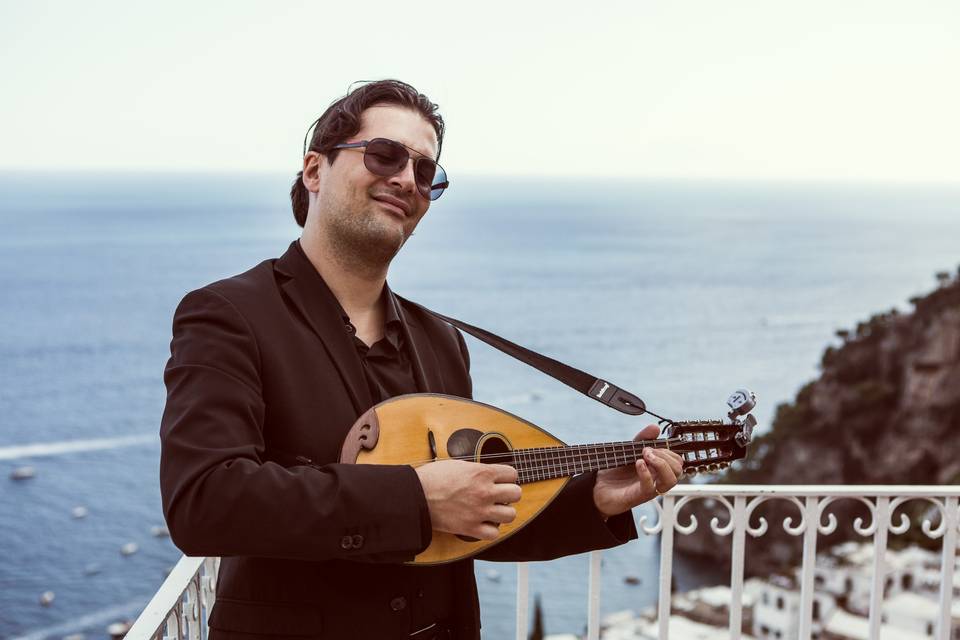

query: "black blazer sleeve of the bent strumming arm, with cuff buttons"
left=160, top=287, right=431, bottom=562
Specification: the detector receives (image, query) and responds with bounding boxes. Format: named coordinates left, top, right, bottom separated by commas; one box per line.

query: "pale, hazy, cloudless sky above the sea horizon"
left=0, top=0, right=960, bottom=183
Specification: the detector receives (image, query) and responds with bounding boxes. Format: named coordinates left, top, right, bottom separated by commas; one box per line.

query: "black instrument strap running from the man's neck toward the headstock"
left=394, top=294, right=653, bottom=416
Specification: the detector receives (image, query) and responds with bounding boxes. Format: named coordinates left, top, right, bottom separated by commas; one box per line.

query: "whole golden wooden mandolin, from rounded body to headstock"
left=340, top=390, right=756, bottom=565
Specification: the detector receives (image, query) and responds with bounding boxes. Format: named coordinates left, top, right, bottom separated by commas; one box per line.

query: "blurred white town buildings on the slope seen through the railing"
left=600, top=543, right=960, bottom=640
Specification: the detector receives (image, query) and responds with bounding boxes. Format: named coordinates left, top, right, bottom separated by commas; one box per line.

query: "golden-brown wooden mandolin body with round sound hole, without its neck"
left=340, top=393, right=569, bottom=565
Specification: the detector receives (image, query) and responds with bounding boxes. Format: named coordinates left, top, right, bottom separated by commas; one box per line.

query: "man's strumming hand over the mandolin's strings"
left=416, top=460, right=520, bottom=540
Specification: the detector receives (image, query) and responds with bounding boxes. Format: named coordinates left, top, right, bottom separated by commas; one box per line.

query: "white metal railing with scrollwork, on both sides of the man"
left=127, top=485, right=960, bottom=640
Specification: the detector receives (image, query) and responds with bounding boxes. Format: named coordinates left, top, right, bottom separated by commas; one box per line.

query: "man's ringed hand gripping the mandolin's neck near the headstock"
left=593, top=424, right=683, bottom=517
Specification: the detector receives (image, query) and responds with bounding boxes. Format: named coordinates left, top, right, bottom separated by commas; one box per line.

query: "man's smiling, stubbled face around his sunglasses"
left=304, top=105, right=437, bottom=265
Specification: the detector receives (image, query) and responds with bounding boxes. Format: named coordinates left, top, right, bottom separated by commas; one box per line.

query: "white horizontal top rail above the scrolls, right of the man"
left=666, top=484, right=960, bottom=498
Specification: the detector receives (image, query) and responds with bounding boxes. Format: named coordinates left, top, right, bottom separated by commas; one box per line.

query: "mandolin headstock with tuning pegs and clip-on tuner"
left=663, top=389, right=757, bottom=476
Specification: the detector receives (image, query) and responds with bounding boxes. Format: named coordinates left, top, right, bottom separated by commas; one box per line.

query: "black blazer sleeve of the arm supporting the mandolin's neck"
left=454, top=329, right=637, bottom=562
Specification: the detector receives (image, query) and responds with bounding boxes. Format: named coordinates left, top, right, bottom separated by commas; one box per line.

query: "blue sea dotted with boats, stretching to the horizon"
left=0, top=172, right=960, bottom=640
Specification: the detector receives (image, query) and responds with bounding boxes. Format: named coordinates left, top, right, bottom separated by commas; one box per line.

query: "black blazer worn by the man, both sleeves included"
left=160, top=241, right=636, bottom=640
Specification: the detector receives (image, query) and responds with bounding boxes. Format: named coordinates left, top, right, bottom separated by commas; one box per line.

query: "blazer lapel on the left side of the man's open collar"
left=273, top=240, right=373, bottom=415
